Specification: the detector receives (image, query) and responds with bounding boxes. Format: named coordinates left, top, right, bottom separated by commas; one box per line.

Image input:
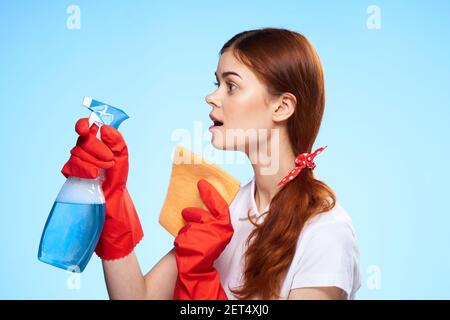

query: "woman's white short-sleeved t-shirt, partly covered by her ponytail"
left=214, top=177, right=361, bottom=300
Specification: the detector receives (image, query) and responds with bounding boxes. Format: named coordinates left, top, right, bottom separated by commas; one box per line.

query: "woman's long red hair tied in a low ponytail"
left=220, top=28, right=336, bottom=299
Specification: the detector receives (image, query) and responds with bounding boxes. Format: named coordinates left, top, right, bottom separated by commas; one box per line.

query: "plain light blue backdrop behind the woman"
left=0, top=0, right=450, bottom=299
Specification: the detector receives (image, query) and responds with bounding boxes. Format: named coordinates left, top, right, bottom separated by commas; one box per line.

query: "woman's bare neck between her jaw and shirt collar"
left=247, top=130, right=296, bottom=213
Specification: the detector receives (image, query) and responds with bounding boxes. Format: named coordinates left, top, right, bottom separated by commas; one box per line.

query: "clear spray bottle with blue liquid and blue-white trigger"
left=38, top=97, right=128, bottom=273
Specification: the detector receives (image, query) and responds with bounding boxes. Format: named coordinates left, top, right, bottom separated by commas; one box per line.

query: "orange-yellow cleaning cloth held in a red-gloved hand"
left=159, top=146, right=240, bottom=236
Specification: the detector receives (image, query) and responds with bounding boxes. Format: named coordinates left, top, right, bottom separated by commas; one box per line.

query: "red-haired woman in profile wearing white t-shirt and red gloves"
left=62, top=28, right=360, bottom=299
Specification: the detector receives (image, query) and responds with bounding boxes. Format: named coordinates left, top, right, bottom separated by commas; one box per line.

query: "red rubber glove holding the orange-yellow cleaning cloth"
left=173, top=179, right=234, bottom=300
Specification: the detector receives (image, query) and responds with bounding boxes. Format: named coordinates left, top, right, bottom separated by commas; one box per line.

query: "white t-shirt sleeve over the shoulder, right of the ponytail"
left=291, top=202, right=360, bottom=298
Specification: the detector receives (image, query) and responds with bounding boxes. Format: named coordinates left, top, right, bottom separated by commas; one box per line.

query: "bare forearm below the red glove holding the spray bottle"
left=102, top=251, right=147, bottom=300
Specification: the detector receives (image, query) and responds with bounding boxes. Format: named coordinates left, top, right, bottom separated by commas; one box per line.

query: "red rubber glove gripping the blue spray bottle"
left=61, top=118, right=144, bottom=260
